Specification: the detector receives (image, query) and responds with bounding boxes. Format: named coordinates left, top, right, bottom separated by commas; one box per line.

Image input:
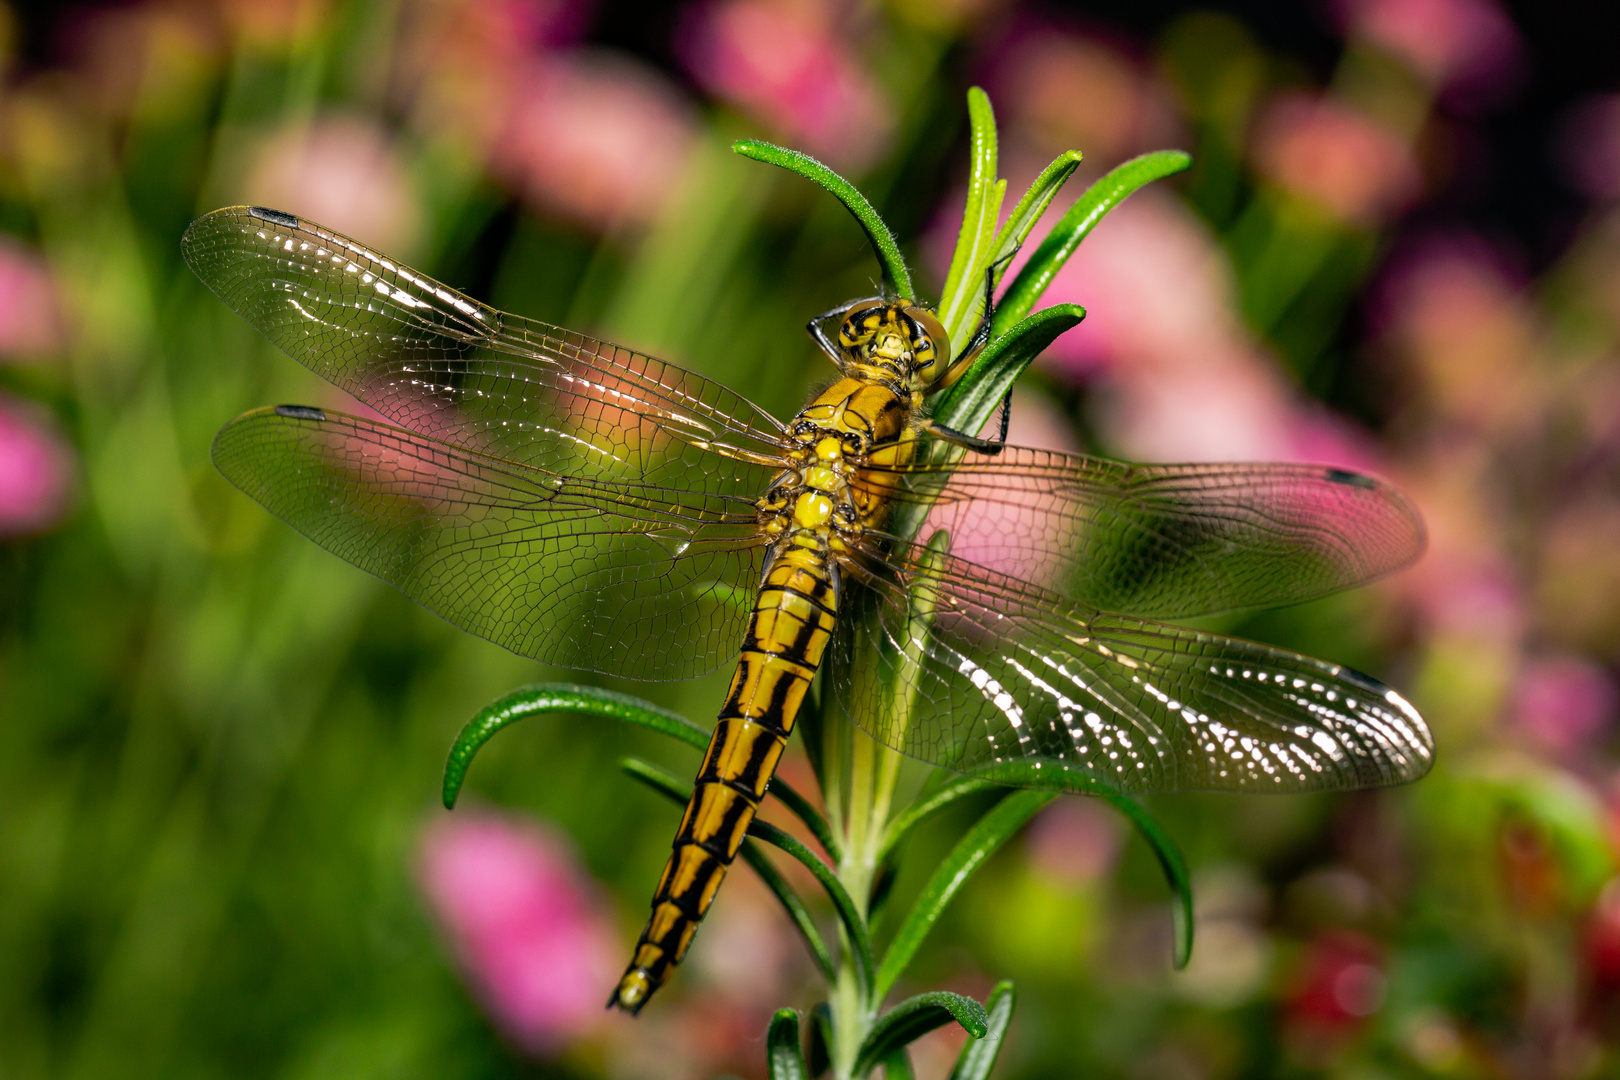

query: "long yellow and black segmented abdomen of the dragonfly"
left=608, top=544, right=838, bottom=1014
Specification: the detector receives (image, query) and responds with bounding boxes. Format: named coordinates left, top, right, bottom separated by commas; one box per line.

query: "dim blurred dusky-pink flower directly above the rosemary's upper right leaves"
left=991, top=23, right=1178, bottom=167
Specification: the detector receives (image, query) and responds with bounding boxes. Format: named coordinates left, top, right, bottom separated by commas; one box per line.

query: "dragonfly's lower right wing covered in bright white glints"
left=828, top=547, right=1434, bottom=792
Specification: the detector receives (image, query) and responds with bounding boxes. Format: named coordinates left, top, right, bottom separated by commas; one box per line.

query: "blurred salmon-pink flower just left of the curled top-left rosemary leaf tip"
left=489, top=52, right=695, bottom=230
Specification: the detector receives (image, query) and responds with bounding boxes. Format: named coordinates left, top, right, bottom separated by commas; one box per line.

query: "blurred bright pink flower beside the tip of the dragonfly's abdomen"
left=418, top=811, right=619, bottom=1054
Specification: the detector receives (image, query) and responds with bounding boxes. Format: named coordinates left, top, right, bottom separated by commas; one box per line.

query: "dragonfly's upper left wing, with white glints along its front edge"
left=181, top=206, right=782, bottom=499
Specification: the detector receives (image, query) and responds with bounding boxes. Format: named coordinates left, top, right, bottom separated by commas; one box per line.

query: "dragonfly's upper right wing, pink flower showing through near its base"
left=862, top=447, right=1424, bottom=619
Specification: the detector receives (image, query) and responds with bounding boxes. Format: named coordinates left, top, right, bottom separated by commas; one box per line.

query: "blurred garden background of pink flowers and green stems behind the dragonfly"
left=0, top=0, right=1620, bottom=1080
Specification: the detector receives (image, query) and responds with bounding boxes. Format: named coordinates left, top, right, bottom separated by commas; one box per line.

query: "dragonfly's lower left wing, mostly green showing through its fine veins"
left=214, top=406, right=763, bottom=678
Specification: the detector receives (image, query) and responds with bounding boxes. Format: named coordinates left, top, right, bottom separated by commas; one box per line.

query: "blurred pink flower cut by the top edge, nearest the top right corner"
left=1338, top=0, right=1521, bottom=96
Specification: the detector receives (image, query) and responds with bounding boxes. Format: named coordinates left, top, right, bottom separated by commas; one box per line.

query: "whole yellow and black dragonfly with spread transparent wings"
left=181, top=207, right=1434, bottom=1014
